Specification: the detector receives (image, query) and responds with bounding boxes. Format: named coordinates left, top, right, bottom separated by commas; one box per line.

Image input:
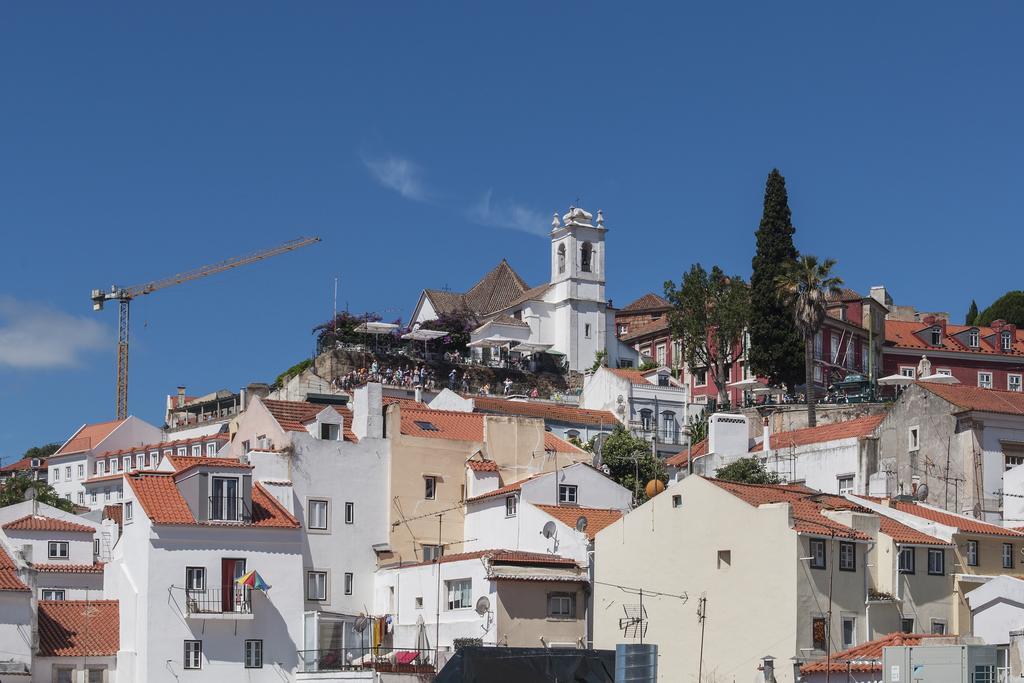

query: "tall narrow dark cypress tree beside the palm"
left=750, top=168, right=804, bottom=388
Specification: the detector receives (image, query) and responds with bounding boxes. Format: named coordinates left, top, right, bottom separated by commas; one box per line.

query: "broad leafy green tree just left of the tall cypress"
left=665, top=263, right=751, bottom=403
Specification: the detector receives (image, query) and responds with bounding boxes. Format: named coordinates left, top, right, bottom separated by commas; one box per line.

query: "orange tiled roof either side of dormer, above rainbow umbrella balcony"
left=125, top=473, right=299, bottom=528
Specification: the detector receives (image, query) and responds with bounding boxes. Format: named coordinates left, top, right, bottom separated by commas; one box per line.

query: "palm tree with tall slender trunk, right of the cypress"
left=775, top=254, right=843, bottom=427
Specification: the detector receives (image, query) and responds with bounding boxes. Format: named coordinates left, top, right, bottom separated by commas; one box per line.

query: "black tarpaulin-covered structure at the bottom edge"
left=434, top=647, right=615, bottom=683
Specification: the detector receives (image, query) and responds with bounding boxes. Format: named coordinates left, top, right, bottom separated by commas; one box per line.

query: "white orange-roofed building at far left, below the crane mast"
left=47, top=416, right=163, bottom=508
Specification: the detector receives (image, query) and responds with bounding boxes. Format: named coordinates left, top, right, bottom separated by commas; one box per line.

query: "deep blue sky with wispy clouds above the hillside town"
left=0, top=2, right=1024, bottom=459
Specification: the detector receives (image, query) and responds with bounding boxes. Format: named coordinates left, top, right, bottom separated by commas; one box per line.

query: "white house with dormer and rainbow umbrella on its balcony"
left=111, top=457, right=304, bottom=683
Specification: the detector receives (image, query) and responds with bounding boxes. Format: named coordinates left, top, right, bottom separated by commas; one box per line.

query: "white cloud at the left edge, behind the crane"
left=0, top=295, right=110, bottom=370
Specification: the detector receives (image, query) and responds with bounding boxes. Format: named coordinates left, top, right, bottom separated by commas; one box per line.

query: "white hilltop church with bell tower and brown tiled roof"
left=412, top=207, right=637, bottom=372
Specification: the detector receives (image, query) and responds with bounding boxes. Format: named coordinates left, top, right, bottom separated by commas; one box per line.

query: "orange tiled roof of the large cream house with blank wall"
left=708, top=479, right=870, bottom=541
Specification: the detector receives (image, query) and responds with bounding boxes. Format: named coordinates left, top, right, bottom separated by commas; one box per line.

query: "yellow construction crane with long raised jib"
left=92, top=238, right=321, bottom=420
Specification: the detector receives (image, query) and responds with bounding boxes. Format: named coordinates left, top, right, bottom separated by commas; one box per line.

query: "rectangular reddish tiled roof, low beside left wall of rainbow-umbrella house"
left=39, top=600, right=121, bottom=657
